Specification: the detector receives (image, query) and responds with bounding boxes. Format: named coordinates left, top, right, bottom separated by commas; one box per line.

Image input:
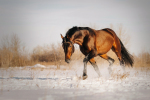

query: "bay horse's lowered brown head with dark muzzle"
left=61, top=34, right=75, bottom=63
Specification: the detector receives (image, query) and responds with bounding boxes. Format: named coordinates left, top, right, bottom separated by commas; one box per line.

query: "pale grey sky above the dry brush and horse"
left=0, top=0, right=150, bottom=54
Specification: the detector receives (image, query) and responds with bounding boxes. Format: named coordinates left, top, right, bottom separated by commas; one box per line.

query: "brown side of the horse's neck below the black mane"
left=72, top=30, right=88, bottom=46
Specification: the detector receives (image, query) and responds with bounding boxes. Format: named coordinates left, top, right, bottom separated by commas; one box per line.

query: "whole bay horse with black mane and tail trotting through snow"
left=61, top=26, right=134, bottom=80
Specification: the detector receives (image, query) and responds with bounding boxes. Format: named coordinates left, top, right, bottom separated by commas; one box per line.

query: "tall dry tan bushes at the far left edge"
left=0, top=34, right=31, bottom=67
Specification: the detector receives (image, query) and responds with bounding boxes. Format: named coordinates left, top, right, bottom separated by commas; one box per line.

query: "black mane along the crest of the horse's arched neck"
left=65, top=26, right=94, bottom=39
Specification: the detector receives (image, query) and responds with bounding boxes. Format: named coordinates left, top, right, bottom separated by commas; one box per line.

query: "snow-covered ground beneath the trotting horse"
left=0, top=63, right=150, bottom=100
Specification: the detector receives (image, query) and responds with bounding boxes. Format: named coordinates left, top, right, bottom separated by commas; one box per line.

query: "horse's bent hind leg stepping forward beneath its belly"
left=99, top=54, right=115, bottom=74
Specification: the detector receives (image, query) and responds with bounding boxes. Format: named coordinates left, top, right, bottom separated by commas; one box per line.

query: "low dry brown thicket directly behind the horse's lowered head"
left=31, top=43, right=84, bottom=68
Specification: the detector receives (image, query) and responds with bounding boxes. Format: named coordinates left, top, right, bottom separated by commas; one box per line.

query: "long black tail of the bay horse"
left=119, top=39, right=134, bottom=67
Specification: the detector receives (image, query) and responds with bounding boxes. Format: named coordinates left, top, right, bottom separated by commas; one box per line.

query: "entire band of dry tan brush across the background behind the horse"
left=0, top=24, right=150, bottom=69
